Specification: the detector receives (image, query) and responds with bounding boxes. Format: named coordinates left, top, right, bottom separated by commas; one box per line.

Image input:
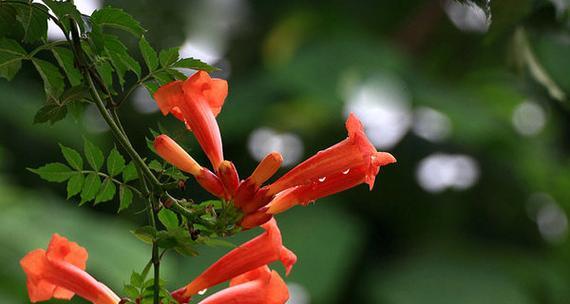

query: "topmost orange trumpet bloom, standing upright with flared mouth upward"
left=154, top=71, right=228, bottom=171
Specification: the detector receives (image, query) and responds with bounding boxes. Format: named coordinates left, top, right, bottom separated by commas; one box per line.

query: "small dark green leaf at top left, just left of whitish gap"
left=16, top=2, right=48, bottom=42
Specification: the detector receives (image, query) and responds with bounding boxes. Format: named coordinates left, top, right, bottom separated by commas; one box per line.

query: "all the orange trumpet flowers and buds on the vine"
left=20, top=71, right=396, bottom=304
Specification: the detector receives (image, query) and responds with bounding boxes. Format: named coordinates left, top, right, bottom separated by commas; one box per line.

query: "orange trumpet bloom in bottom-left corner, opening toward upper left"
left=20, top=234, right=120, bottom=304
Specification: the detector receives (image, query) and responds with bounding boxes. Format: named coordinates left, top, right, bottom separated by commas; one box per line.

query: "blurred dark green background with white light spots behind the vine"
left=0, top=0, right=570, bottom=304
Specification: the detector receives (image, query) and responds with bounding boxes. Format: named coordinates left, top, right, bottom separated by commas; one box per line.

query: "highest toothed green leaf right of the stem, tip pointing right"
left=91, top=6, right=145, bottom=37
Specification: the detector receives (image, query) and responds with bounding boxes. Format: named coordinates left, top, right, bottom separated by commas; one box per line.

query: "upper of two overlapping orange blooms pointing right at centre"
left=267, top=113, right=396, bottom=195
